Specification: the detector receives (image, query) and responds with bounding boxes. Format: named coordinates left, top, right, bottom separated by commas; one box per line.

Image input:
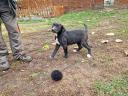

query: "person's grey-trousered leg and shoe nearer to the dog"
left=1, top=12, right=32, bottom=62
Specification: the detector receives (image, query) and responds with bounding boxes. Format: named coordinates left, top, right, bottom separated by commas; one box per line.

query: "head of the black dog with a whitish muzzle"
left=52, top=23, right=65, bottom=33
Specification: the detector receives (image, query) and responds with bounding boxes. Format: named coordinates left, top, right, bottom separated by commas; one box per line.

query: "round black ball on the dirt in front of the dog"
left=51, top=70, right=63, bottom=81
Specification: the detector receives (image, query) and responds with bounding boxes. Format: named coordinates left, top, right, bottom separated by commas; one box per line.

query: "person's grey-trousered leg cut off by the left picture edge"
left=0, top=21, right=10, bottom=71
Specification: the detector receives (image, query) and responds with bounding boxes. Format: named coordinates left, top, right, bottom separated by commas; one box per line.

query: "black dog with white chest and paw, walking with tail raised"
left=51, top=23, right=92, bottom=58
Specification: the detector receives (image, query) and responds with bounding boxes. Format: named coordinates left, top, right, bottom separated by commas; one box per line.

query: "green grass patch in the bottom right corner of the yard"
left=94, top=77, right=128, bottom=96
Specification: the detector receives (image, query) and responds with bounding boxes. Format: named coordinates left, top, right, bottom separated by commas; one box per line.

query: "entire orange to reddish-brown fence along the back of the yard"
left=17, top=0, right=104, bottom=18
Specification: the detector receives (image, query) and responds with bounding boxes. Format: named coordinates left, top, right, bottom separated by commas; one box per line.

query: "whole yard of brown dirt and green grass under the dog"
left=0, top=9, right=128, bottom=96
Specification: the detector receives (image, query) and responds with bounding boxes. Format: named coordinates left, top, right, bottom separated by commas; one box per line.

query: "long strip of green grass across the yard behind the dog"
left=3, top=10, right=128, bottom=34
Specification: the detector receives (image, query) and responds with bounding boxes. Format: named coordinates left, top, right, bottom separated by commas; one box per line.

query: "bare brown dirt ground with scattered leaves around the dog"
left=0, top=11, right=128, bottom=96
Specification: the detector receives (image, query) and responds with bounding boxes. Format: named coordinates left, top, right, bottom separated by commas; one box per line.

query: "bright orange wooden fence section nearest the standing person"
left=18, top=0, right=64, bottom=18
